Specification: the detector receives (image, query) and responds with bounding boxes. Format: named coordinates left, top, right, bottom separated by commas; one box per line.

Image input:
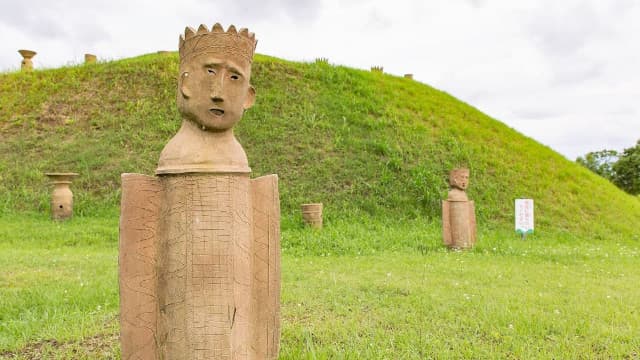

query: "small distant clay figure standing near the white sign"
left=442, top=169, right=476, bottom=249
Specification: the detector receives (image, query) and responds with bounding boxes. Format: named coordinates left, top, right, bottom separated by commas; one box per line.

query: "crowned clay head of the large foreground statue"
left=177, top=23, right=256, bottom=131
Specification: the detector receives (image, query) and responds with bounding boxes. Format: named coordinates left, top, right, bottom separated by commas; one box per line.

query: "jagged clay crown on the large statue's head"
left=179, top=23, right=257, bottom=65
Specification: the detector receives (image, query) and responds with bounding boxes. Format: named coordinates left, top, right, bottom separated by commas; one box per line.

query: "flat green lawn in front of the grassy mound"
left=0, top=214, right=640, bottom=359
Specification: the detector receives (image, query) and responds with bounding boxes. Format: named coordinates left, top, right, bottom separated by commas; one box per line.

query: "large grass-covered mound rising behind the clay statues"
left=0, top=54, right=640, bottom=238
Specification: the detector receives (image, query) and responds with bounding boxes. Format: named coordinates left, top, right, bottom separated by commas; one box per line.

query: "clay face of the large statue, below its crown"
left=178, top=54, right=255, bottom=131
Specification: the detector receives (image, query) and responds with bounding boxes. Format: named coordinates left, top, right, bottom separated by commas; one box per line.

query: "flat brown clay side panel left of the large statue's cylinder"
left=118, top=174, right=162, bottom=360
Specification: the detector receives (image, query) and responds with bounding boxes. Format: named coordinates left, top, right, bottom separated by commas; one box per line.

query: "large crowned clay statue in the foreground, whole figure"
left=119, top=24, right=280, bottom=359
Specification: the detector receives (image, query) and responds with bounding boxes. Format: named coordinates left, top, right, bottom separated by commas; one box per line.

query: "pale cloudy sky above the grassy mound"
left=0, top=0, right=640, bottom=160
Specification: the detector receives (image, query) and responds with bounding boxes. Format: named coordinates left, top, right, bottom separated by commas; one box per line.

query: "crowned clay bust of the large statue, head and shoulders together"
left=156, top=24, right=256, bottom=175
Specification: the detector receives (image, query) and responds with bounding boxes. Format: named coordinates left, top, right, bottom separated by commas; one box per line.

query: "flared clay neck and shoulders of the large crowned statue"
left=156, top=119, right=251, bottom=175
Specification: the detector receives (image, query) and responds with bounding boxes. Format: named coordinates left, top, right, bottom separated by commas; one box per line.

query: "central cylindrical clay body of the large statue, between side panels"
left=158, top=174, right=252, bottom=359
